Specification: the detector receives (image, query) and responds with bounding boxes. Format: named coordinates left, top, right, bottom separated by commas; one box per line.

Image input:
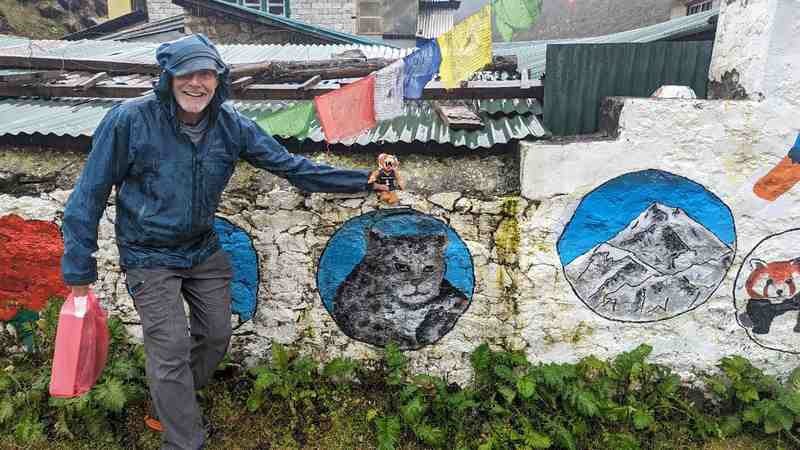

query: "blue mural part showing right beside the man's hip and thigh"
left=214, top=217, right=260, bottom=326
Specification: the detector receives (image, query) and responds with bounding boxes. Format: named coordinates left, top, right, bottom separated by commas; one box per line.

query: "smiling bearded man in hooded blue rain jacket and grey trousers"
left=62, top=35, right=381, bottom=449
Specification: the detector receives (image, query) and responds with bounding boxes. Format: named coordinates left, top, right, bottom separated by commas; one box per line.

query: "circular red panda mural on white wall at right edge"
left=733, top=228, right=800, bottom=353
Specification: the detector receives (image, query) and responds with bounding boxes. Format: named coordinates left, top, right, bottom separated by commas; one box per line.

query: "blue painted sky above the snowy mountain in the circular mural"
left=557, top=169, right=736, bottom=266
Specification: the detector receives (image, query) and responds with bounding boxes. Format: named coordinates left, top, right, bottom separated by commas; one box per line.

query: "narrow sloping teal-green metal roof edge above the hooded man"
left=173, top=0, right=387, bottom=46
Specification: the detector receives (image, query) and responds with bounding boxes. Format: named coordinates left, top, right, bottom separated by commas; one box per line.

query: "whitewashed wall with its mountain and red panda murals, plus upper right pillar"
left=518, top=0, right=800, bottom=374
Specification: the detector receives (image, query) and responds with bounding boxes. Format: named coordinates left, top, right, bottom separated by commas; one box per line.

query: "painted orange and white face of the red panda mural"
left=746, top=259, right=800, bottom=300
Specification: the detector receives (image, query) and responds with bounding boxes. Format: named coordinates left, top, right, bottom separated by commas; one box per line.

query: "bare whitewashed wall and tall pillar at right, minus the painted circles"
left=518, top=0, right=800, bottom=375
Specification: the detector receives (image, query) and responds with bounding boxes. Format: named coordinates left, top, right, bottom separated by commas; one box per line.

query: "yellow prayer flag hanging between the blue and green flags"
left=436, top=4, right=492, bottom=89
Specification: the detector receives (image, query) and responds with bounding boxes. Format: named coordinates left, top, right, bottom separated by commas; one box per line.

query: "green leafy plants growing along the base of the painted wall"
left=0, top=301, right=800, bottom=450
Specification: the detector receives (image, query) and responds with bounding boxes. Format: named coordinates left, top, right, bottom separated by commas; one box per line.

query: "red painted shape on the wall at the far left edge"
left=0, top=214, right=68, bottom=321
